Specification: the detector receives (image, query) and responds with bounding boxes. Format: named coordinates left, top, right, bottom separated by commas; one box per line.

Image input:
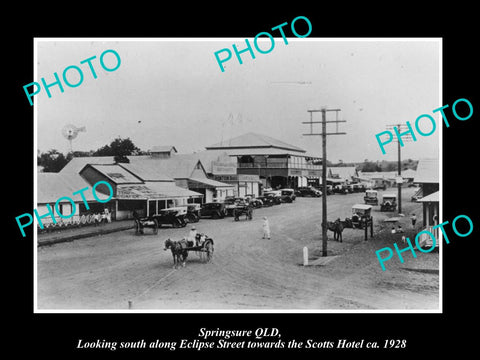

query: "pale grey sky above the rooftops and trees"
left=32, top=37, right=443, bottom=162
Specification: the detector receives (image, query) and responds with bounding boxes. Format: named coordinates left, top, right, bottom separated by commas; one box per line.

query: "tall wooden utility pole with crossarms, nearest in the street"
left=302, top=107, right=347, bottom=256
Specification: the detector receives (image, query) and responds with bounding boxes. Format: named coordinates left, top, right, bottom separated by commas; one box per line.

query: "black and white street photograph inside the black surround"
left=34, top=38, right=440, bottom=312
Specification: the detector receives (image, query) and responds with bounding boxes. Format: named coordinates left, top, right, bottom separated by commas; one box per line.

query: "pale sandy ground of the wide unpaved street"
left=37, top=188, right=439, bottom=310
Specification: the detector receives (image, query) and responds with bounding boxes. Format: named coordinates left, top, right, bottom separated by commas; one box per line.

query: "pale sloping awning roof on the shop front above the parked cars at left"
left=116, top=182, right=203, bottom=200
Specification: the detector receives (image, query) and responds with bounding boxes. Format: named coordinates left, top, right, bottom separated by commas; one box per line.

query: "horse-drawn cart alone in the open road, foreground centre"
left=163, top=234, right=214, bottom=269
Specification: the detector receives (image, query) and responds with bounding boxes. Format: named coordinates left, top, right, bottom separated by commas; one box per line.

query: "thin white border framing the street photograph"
left=32, top=37, right=443, bottom=314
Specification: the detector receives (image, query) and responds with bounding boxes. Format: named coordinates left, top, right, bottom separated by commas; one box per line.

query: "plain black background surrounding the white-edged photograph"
left=6, top=2, right=480, bottom=358
